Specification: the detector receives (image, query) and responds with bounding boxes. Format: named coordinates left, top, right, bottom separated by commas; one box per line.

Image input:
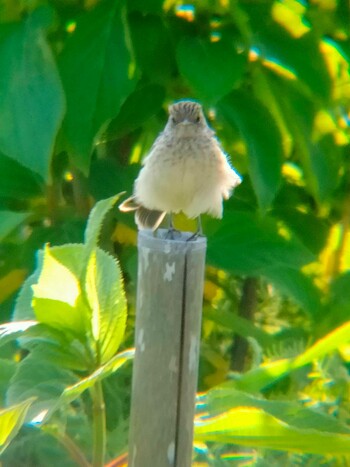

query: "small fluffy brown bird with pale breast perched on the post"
left=119, top=100, right=242, bottom=234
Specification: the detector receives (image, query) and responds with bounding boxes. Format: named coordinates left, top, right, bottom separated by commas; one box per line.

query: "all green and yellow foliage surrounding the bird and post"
left=0, top=0, right=350, bottom=466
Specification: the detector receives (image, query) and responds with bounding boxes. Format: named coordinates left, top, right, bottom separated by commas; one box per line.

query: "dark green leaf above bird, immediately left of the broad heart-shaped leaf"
left=128, top=13, right=175, bottom=83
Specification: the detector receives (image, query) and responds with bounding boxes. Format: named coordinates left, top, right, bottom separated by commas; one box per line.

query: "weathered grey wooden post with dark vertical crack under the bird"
left=128, top=230, right=206, bottom=467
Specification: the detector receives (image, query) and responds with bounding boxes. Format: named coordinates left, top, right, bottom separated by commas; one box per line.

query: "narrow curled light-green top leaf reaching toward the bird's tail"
left=85, top=194, right=120, bottom=255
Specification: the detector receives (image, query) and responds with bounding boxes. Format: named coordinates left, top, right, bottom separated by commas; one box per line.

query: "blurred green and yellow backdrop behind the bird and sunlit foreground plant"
left=0, top=0, right=350, bottom=466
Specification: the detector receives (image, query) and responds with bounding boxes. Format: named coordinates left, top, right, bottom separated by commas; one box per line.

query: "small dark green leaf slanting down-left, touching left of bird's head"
left=107, top=84, right=165, bottom=138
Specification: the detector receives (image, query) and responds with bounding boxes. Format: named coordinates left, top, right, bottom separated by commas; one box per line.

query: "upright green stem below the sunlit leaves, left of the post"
left=92, top=381, right=106, bottom=467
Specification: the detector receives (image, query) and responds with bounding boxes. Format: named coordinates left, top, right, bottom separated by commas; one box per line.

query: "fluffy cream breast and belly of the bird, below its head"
left=135, top=134, right=238, bottom=217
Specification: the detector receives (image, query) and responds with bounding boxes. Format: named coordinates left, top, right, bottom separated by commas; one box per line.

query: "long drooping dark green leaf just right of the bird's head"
left=218, top=91, right=283, bottom=210
